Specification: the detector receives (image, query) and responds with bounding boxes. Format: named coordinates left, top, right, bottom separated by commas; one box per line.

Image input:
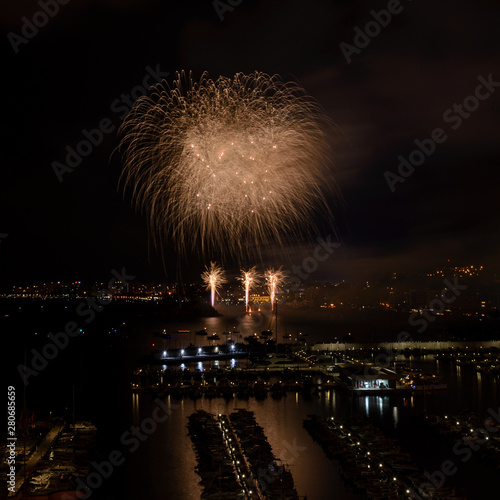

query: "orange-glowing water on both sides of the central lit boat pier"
left=120, top=391, right=360, bottom=500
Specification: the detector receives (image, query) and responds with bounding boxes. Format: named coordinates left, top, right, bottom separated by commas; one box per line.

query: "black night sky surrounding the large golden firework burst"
left=0, top=0, right=500, bottom=284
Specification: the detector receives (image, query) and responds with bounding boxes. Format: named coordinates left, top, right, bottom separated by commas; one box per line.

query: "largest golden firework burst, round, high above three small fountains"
left=120, top=72, right=331, bottom=254
